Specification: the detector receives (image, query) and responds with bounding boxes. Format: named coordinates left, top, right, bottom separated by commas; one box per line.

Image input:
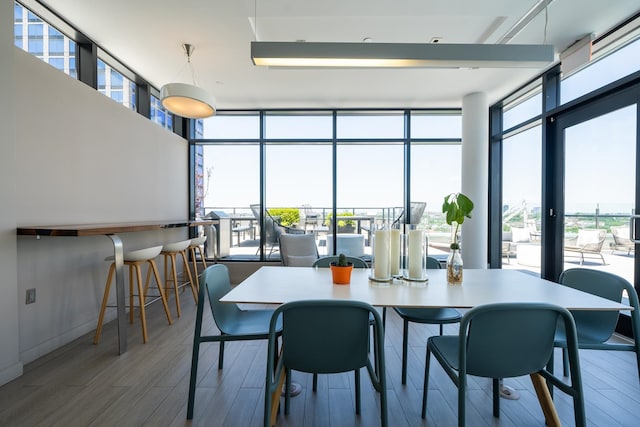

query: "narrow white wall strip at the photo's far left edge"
left=0, top=1, right=22, bottom=384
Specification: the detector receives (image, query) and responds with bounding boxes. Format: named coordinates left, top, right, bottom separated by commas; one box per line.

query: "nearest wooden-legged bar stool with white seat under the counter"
left=93, top=246, right=172, bottom=344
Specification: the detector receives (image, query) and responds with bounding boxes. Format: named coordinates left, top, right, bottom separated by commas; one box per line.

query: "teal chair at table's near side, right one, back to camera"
left=422, top=303, right=586, bottom=426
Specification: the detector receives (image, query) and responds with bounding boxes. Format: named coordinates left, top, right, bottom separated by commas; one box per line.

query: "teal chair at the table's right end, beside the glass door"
left=550, top=268, right=640, bottom=378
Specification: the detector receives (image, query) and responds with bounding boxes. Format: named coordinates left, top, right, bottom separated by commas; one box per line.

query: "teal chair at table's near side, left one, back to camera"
left=264, top=300, right=388, bottom=427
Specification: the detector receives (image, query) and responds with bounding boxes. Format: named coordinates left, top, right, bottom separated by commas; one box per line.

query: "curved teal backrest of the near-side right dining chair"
left=459, top=303, right=575, bottom=378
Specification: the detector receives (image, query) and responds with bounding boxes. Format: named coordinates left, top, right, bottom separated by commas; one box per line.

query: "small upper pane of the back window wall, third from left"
left=337, top=113, right=404, bottom=139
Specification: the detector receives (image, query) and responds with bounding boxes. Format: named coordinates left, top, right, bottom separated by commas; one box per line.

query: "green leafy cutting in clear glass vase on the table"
left=442, top=193, right=473, bottom=284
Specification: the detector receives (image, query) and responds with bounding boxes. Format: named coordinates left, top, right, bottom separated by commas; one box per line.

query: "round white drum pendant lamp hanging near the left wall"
left=160, top=44, right=216, bottom=119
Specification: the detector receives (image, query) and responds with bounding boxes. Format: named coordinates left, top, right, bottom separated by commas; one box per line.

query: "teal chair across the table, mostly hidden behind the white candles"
left=393, top=257, right=462, bottom=384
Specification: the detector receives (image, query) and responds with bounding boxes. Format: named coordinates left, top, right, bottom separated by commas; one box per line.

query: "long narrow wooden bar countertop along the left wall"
left=16, top=219, right=218, bottom=236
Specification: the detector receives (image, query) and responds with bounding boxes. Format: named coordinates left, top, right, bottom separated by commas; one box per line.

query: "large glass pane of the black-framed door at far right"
left=564, top=105, right=637, bottom=283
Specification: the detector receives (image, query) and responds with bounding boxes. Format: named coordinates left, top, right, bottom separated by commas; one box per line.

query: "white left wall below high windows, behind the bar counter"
left=0, top=34, right=188, bottom=384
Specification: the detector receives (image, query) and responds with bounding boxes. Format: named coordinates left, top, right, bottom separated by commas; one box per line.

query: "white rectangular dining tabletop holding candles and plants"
left=220, top=266, right=630, bottom=310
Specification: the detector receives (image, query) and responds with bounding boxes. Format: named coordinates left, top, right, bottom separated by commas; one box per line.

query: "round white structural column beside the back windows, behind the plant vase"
left=461, top=92, right=489, bottom=268
